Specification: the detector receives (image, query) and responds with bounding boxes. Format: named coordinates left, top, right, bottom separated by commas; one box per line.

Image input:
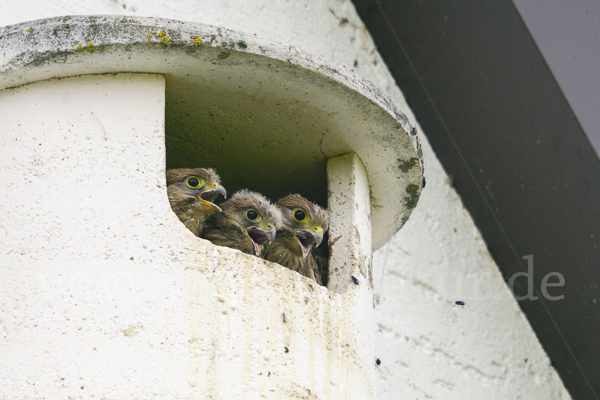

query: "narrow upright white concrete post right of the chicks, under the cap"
left=327, top=153, right=375, bottom=398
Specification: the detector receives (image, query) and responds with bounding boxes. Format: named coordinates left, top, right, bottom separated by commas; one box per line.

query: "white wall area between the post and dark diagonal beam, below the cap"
left=373, top=145, right=571, bottom=400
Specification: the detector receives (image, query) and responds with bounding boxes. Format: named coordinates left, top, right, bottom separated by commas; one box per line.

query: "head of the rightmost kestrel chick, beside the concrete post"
left=277, top=194, right=329, bottom=258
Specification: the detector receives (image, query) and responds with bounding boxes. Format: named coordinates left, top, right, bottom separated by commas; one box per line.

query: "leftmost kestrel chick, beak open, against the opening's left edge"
left=167, top=168, right=227, bottom=236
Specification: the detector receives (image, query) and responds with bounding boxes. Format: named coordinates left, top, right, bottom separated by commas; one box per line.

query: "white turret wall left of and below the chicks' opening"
left=0, top=74, right=374, bottom=400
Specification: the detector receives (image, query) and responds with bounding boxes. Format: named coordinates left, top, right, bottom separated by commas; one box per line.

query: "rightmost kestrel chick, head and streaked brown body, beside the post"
left=263, top=194, right=329, bottom=285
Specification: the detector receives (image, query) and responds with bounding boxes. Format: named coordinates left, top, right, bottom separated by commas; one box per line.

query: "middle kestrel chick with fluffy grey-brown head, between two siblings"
left=202, top=190, right=282, bottom=255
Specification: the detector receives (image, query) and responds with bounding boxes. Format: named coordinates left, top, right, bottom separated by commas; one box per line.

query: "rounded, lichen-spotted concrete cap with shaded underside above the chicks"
left=0, top=16, right=423, bottom=250
